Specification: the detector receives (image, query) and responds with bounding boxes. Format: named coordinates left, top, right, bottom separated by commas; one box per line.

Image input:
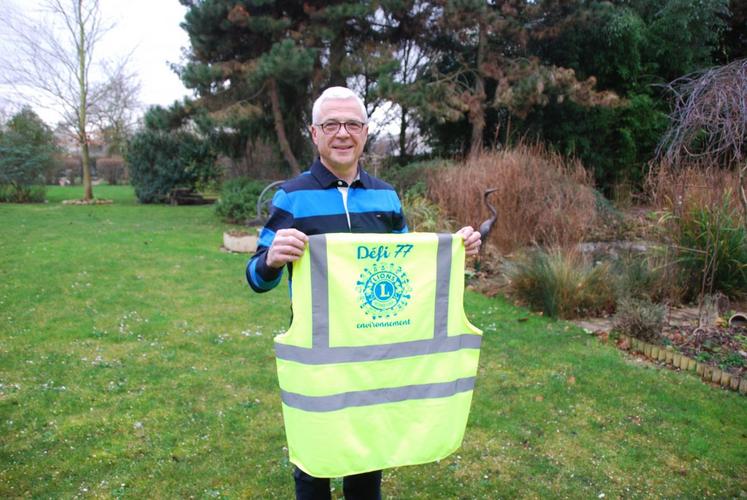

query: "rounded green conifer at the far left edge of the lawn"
left=0, top=106, right=57, bottom=201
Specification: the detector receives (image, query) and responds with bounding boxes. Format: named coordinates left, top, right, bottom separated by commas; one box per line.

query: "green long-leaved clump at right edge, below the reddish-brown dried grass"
left=663, top=191, right=747, bottom=298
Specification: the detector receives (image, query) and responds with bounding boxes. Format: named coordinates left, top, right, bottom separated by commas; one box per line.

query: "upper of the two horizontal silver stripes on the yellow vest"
left=275, top=334, right=482, bottom=365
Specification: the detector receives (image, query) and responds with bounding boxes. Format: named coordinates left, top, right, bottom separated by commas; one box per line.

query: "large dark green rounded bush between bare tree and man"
left=126, top=129, right=217, bottom=203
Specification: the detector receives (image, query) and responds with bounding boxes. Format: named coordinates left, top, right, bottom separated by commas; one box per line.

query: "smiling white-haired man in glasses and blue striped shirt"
left=246, top=87, right=480, bottom=499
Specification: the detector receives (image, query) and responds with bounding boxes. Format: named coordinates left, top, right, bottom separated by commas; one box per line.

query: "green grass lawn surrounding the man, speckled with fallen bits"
left=0, top=186, right=747, bottom=499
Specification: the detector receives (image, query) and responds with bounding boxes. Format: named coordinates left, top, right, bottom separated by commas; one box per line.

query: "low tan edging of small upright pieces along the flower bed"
left=619, top=333, right=747, bottom=396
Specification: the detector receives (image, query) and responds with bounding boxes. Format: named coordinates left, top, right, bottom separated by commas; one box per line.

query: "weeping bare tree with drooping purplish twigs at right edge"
left=657, top=59, right=747, bottom=216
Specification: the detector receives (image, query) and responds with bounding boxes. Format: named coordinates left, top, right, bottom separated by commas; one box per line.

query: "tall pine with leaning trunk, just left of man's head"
left=178, top=0, right=387, bottom=174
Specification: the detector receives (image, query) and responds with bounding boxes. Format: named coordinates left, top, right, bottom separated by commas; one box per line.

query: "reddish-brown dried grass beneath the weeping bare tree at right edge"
left=646, top=163, right=740, bottom=216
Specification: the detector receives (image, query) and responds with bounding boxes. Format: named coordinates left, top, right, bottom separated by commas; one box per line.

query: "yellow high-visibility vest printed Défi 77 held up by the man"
left=275, top=233, right=482, bottom=477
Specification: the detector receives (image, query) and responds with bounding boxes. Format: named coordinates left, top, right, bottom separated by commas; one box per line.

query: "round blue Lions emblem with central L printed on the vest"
left=356, top=263, right=412, bottom=319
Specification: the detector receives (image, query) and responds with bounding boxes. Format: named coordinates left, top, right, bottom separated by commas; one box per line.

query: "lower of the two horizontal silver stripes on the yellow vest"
left=280, top=377, right=475, bottom=412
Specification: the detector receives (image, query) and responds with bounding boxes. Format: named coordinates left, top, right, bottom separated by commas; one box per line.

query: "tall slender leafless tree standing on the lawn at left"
left=0, top=0, right=129, bottom=200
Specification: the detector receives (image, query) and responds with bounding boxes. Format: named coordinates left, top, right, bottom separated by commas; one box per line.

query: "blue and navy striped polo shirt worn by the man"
left=246, top=158, right=407, bottom=292
